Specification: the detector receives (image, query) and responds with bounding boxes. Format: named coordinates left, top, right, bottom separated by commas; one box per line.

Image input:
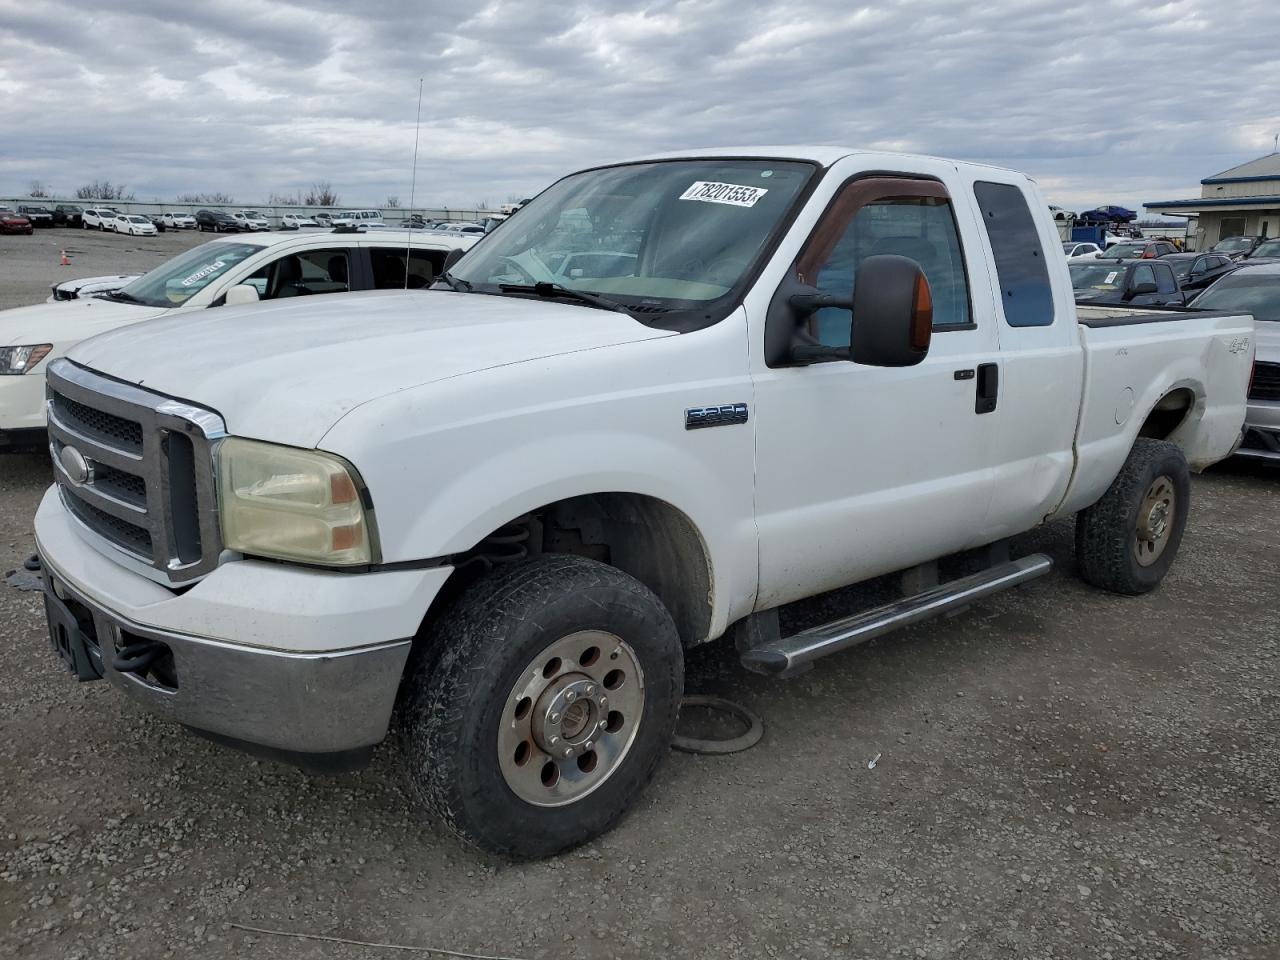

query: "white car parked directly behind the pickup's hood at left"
left=0, top=230, right=475, bottom=449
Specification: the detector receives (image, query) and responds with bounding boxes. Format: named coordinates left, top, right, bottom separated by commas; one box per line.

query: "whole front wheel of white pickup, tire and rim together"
left=399, top=556, right=684, bottom=858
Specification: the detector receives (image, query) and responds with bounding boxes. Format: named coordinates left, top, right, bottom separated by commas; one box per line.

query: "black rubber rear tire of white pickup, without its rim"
left=1075, top=439, right=1192, bottom=595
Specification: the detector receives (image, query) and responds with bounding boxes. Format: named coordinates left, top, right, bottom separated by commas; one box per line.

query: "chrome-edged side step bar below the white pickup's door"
left=742, top=553, right=1053, bottom=676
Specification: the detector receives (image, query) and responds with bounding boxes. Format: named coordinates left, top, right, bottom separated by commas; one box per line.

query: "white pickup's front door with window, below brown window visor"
left=753, top=167, right=1001, bottom=609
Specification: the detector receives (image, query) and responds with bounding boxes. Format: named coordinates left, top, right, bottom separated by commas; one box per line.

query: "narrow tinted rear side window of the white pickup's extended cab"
left=973, top=182, right=1053, bottom=326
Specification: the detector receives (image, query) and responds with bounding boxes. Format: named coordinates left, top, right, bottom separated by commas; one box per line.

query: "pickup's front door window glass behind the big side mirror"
left=799, top=180, right=972, bottom=347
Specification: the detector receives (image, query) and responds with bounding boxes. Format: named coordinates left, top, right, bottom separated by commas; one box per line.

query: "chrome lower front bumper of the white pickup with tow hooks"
left=44, top=562, right=410, bottom=768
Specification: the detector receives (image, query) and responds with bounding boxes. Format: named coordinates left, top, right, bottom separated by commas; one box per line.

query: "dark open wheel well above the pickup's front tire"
left=419, top=493, right=712, bottom=646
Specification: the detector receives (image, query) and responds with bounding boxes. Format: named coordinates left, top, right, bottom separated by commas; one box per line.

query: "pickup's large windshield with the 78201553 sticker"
left=451, top=160, right=814, bottom=321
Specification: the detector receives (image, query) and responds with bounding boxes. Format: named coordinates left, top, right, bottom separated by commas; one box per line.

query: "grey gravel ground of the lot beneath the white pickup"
left=0, top=232, right=1280, bottom=960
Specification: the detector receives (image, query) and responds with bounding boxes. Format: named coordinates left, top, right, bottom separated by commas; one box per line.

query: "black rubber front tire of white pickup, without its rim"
left=398, top=554, right=685, bottom=858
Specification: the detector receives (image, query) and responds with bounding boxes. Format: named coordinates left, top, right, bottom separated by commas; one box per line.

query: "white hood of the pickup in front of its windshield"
left=68, top=291, right=673, bottom=447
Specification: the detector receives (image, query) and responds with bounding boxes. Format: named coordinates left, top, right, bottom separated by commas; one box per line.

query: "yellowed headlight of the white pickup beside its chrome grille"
left=218, top=436, right=378, bottom=567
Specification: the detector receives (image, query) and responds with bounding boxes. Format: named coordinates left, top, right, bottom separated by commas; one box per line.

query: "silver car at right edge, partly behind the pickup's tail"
left=1192, top=262, right=1280, bottom=463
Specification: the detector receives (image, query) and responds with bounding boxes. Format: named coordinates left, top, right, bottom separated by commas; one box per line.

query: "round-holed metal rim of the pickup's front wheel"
left=498, top=630, right=645, bottom=806
